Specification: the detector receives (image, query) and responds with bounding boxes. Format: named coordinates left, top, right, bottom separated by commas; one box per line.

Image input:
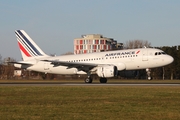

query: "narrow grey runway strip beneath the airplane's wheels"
left=0, top=82, right=180, bottom=87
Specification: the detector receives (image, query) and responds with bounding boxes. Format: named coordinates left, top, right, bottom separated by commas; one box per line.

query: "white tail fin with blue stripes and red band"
left=15, top=30, right=48, bottom=61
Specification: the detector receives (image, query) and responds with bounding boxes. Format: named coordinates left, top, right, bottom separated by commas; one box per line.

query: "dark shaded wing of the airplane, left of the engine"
left=42, top=60, right=98, bottom=72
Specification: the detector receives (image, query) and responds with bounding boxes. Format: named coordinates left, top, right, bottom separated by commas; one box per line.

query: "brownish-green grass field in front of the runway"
left=0, top=86, right=180, bottom=120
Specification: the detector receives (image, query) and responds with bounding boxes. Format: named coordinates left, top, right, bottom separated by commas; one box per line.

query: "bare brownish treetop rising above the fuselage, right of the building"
left=124, top=40, right=151, bottom=49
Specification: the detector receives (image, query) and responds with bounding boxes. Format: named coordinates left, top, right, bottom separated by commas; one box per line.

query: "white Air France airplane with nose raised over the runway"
left=14, top=30, right=174, bottom=83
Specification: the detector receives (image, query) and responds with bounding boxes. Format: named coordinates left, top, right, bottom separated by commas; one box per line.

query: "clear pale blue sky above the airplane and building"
left=0, top=0, right=180, bottom=60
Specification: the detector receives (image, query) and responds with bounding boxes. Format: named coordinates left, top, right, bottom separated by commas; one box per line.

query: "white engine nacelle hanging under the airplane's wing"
left=96, top=65, right=118, bottom=78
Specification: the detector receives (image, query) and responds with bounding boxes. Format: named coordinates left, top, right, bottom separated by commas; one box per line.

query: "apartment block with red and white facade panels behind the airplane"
left=74, top=34, right=123, bottom=54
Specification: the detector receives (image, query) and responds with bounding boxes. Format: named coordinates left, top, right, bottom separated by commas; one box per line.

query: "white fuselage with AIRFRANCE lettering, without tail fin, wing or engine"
left=15, top=48, right=173, bottom=74
